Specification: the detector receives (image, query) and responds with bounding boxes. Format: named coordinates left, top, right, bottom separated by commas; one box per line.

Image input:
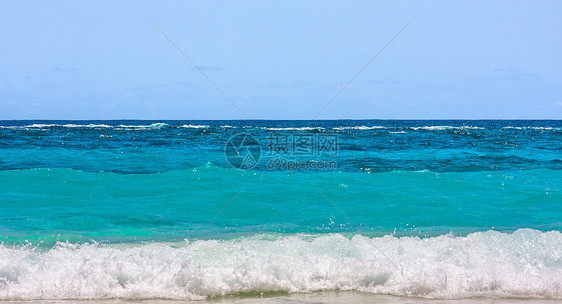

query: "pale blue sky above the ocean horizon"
left=0, top=0, right=562, bottom=120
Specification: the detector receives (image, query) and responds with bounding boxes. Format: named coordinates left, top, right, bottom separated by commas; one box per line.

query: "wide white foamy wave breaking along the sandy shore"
left=0, top=229, right=562, bottom=300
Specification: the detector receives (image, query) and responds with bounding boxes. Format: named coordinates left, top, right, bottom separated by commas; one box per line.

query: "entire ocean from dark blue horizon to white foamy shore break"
left=0, top=120, right=562, bottom=303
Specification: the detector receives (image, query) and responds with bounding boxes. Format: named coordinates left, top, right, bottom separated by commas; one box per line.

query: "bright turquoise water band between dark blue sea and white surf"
left=0, top=164, right=562, bottom=245
